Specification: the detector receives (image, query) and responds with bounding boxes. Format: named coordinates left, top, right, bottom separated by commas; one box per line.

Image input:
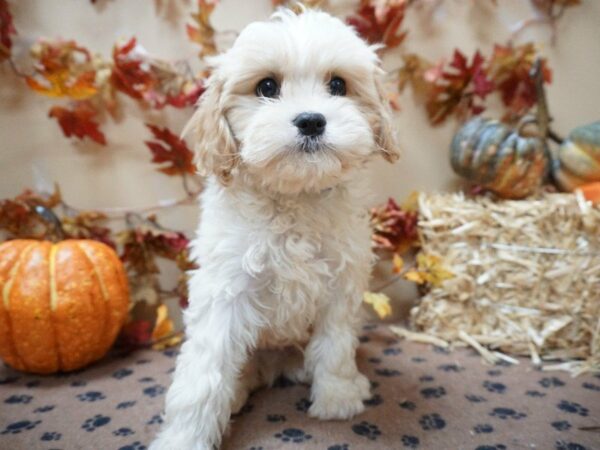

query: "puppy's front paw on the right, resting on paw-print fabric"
left=308, top=374, right=370, bottom=420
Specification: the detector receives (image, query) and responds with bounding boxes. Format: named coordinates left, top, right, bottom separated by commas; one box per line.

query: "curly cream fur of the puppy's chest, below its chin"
left=242, top=205, right=356, bottom=334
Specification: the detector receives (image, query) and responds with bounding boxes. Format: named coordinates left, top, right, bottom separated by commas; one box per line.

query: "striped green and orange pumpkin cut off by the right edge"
left=552, top=122, right=600, bottom=191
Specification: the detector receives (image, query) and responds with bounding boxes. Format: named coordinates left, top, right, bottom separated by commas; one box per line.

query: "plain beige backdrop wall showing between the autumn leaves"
left=0, top=0, right=600, bottom=316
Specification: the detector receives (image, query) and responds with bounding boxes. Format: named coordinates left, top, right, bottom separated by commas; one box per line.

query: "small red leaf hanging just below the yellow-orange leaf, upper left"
left=48, top=102, right=106, bottom=145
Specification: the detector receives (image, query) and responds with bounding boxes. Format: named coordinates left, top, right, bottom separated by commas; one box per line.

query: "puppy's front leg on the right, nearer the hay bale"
left=306, top=291, right=370, bottom=420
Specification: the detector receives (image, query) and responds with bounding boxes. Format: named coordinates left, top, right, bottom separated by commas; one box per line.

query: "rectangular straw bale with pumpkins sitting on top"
left=411, top=194, right=600, bottom=374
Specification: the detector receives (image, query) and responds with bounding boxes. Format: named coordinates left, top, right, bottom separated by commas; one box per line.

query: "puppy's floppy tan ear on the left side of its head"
left=182, top=75, right=239, bottom=184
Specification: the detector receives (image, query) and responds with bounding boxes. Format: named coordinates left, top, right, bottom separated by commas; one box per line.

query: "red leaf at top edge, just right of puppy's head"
left=346, top=0, right=406, bottom=48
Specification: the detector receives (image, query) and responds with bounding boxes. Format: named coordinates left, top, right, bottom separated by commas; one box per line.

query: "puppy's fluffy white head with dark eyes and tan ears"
left=188, top=10, right=398, bottom=193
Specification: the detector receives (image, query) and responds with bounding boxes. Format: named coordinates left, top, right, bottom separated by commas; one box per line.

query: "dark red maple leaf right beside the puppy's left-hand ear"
left=145, top=124, right=196, bottom=175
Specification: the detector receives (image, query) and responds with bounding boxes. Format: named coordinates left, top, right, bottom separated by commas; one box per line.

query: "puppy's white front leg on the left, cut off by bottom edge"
left=150, top=295, right=258, bottom=450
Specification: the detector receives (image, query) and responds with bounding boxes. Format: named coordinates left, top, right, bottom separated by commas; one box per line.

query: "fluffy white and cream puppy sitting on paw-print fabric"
left=150, top=10, right=398, bottom=450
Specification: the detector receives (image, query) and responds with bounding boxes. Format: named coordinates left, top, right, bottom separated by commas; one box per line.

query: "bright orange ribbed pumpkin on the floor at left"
left=0, top=240, right=129, bottom=373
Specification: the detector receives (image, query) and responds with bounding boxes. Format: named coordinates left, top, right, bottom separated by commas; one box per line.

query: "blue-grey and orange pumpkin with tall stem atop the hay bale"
left=450, top=117, right=550, bottom=198
